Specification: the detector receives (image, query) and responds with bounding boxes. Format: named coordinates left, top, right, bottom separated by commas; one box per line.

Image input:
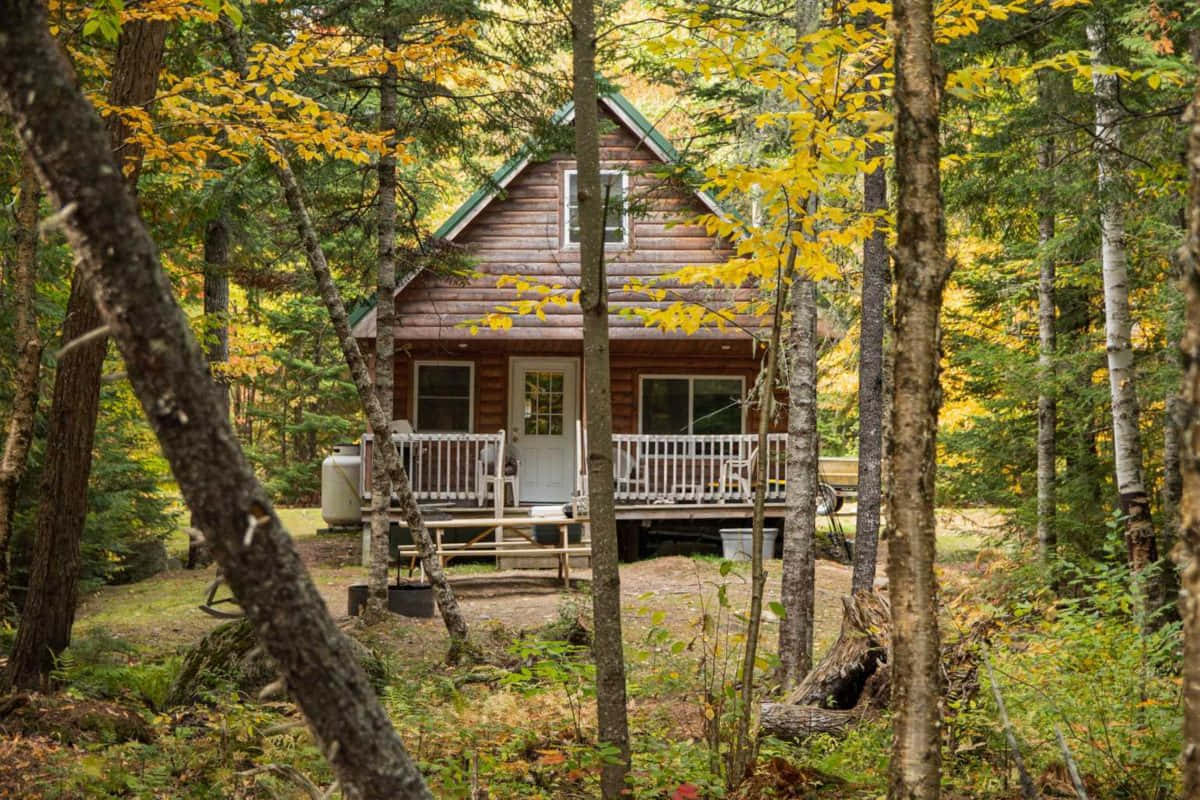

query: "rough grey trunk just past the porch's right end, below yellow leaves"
left=777, top=275, right=820, bottom=691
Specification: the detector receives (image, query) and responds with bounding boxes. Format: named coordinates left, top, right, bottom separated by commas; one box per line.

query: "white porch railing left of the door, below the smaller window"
left=359, top=431, right=504, bottom=509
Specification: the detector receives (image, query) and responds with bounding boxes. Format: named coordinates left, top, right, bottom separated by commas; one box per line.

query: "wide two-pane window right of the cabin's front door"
left=641, top=377, right=743, bottom=434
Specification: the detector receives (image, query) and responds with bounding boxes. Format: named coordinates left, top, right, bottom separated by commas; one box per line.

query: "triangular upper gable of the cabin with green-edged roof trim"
left=352, top=95, right=737, bottom=339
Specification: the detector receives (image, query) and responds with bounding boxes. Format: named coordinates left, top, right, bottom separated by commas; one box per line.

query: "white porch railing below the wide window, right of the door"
left=613, top=433, right=787, bottom=503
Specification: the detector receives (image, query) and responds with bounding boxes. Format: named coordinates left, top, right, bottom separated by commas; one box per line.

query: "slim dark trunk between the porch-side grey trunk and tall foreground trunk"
left=851, top=142, right=889, bottom=594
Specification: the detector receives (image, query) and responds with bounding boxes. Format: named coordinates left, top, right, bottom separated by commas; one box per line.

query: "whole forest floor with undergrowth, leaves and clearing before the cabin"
left=7, top=509, right=1070, bottom=799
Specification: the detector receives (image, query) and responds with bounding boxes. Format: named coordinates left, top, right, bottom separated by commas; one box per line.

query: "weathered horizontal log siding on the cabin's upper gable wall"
left=396, top=107, right=750, bottom=340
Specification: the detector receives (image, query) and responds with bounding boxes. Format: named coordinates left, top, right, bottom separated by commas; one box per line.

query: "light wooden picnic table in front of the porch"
left=396, top=517, right=592, bottom=587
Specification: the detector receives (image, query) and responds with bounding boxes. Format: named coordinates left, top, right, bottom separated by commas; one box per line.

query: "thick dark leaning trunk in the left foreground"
left=0, top=0, right=431, bottom=799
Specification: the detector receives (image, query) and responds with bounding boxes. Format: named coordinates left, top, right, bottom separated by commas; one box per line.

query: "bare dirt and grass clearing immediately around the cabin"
left=78, top=509, right=997, bottom=658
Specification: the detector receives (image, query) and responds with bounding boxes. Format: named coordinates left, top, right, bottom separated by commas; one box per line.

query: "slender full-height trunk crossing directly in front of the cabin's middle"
left=571, top=0, right=630, bottom=800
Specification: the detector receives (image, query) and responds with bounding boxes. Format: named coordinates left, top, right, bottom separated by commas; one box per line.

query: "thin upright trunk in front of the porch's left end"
left=367, top=10, right=396, bottom=612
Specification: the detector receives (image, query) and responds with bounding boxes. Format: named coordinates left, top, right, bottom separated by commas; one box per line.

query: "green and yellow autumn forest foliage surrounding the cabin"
left=0, top=0, right=1200, bottom=798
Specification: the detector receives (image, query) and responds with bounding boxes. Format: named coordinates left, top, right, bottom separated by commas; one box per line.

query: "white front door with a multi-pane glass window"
left=509, top=359, right=578, bottom=503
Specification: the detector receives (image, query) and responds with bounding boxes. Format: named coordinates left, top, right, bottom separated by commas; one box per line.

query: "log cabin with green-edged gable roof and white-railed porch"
left=352, top=94, right=854, bottom=555
